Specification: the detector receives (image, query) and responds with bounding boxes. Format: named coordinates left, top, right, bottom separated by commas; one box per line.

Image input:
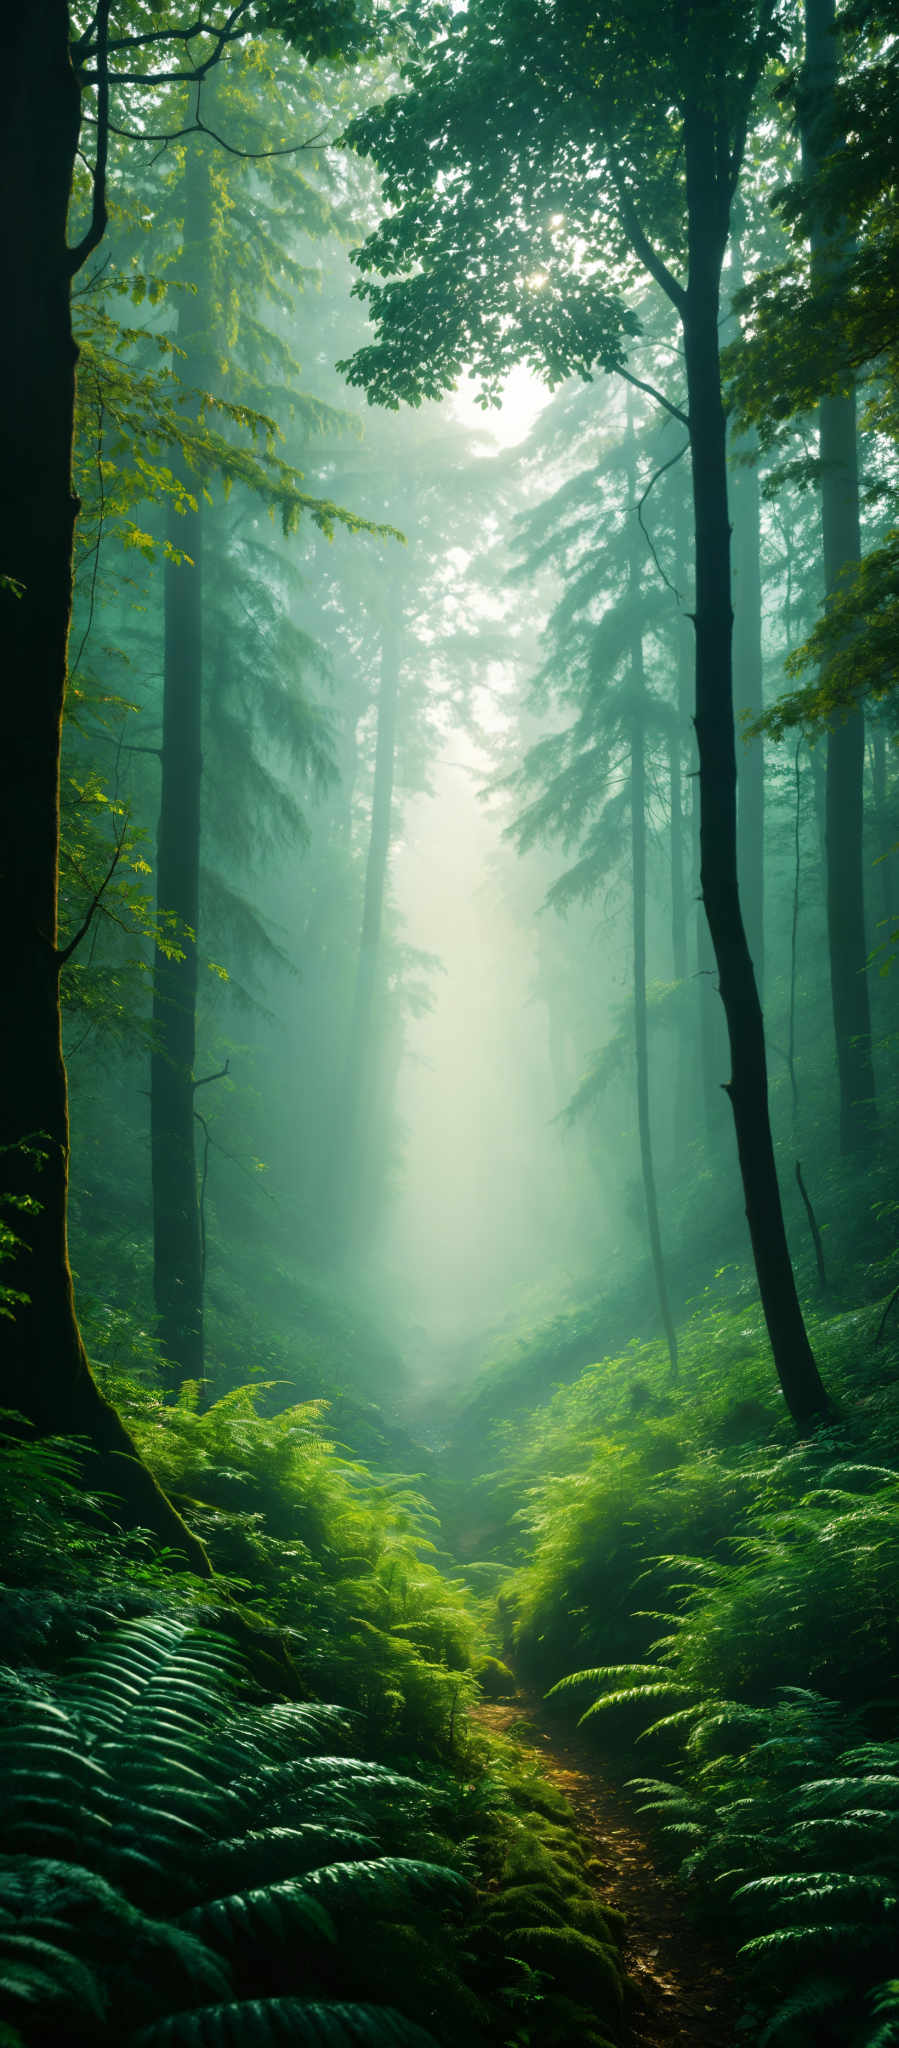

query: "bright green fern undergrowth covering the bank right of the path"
left=454, top=1294, right=899, bottom=2048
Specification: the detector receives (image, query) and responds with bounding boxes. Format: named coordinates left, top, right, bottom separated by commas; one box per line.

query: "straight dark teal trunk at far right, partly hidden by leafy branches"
left=801, top=0, right=876, bottom=1153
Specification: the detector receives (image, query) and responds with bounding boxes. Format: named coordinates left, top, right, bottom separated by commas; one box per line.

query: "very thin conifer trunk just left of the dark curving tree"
left=627, top=405, right=678, bottom=1376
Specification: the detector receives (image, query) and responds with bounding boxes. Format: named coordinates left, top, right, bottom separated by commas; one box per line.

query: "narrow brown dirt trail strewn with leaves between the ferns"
left=475, top=1694, right=737, bottom=2048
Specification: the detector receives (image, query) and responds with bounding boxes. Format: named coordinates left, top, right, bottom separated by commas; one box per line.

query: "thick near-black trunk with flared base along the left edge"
left=0, top=0, right=209, bottom=1575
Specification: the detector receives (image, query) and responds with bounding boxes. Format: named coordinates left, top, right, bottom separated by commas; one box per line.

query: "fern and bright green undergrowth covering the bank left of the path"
left=0, top=1389, right=623, bottom=2048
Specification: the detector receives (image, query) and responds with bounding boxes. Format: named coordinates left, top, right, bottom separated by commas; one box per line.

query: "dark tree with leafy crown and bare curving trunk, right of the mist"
left=350, top=0, right=827, bottom=1425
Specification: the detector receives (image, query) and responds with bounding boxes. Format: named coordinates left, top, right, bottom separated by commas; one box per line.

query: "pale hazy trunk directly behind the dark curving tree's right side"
left=729, top=209, right=764, bottom=995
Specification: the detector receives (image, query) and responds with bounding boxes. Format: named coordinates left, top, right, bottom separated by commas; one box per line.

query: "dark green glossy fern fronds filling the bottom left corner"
left=0, top=1616, right=467, bottom=2044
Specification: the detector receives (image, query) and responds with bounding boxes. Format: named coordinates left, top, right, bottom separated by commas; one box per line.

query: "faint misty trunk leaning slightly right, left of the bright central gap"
left=338, top=586, right=401, bottom=1231
